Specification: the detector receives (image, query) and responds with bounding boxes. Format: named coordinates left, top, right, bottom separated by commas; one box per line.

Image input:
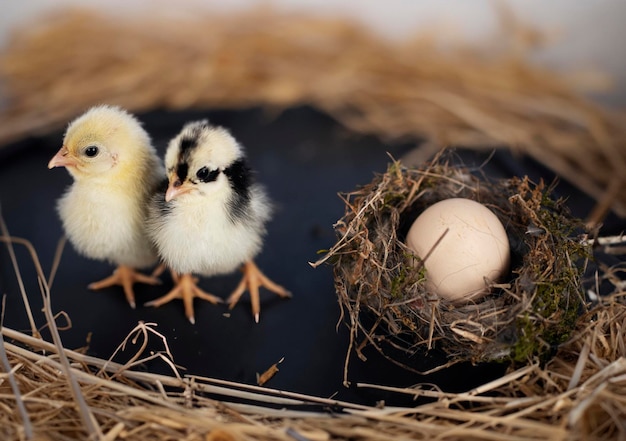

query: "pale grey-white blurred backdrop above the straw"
left=0, top=0, right=626, bottom=105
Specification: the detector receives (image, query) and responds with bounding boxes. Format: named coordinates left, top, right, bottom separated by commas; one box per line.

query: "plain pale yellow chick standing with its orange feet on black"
left=48, top=105, right=163, bottom=308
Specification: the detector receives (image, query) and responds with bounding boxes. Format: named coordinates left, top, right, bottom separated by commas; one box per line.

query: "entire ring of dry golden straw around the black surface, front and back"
left=0, top=6, right=626, bottom=441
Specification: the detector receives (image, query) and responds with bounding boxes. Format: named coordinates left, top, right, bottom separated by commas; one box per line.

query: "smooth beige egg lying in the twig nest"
left=406, top=198, right=510, bottom=303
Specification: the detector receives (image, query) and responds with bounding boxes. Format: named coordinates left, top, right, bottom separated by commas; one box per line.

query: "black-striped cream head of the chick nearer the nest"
left=165, top=120, right=249, bottom=201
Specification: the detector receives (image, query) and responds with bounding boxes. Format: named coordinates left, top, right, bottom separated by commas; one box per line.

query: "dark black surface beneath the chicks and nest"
left=0, top=108, right=623, bottom=404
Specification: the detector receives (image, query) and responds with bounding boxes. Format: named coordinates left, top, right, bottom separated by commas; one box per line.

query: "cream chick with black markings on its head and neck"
left=146, top=120, right=291, bottom=323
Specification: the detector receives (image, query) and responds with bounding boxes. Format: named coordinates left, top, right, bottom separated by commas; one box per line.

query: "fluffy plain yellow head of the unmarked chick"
left=48, top=105, right=158, bottom=186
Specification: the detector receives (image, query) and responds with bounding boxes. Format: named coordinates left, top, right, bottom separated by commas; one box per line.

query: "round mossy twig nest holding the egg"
left=316, top=155, right=591, bottom=370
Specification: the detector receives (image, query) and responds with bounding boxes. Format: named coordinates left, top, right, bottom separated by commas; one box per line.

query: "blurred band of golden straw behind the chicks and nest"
left=0, top=9, right=626, bottom=222
